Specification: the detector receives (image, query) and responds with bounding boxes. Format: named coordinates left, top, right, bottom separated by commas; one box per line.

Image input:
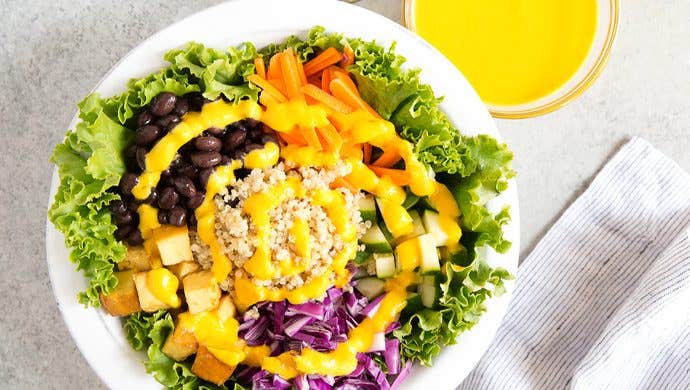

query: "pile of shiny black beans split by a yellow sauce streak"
left=110, top=92, right=279, bottom=245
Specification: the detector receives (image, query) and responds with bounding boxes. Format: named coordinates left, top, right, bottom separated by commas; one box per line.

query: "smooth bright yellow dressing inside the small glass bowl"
left=413, top=0, right=597, bottom=106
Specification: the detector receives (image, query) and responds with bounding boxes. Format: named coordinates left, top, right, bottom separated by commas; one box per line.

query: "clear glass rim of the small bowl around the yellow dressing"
left=402, top=0, right=620, bottom=119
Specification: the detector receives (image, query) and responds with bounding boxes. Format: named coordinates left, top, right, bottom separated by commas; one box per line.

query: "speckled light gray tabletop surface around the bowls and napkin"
left=0, top=0, right=690, bottom=389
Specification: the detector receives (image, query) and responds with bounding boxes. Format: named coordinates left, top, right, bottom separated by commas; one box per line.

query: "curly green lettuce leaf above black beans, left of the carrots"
left=165, top=42, right=258, bottom=101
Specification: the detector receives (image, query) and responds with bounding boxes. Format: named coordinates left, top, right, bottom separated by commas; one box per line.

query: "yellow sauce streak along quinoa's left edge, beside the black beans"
left=195, top=160, right=242, bottom=283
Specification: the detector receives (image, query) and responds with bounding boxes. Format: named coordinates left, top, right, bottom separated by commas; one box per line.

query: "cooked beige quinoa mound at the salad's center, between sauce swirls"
left=190, top=162, right=369, bottom=292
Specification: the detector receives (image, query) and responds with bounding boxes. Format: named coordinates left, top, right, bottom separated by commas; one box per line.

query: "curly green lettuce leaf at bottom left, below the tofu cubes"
left=124, top=310, right=245, bottom=390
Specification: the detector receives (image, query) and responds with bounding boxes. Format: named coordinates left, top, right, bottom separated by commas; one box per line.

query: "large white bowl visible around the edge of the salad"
left=46, top=0, right=519, bottom=389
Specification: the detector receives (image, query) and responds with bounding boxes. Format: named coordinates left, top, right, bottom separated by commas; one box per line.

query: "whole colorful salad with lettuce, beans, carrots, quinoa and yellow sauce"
left=49, top=27, right=514, bottom=389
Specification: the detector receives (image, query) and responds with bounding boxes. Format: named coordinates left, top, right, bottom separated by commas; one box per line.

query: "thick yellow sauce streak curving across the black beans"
left=132, top=100, right=262, bottom=199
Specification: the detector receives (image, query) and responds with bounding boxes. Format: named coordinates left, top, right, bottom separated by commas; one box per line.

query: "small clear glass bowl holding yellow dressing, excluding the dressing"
left=403, top=0, right=620, bottom=119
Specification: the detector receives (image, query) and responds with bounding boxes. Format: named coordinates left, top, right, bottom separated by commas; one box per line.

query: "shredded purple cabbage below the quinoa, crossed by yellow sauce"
left=235, top=287, right=409, bottom=390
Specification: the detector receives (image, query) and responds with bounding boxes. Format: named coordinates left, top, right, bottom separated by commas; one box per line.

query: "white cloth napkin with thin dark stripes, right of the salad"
left=459, top=138, right=690, bottom=390
